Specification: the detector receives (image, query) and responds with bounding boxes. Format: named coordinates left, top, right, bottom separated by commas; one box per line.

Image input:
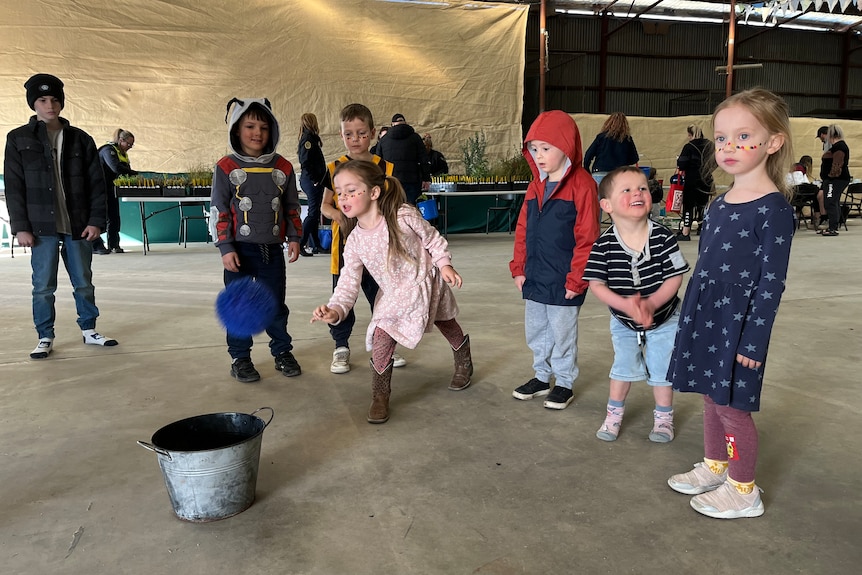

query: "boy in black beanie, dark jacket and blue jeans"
left=4, top=74, right=117, bottom=359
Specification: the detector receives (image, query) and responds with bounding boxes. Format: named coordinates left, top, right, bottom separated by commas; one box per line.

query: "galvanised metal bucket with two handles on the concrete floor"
left=138, top=407, right=275, bottom=522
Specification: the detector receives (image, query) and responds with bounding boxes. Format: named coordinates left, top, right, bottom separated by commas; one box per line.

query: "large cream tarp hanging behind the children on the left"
left=0, top=0, right=527, bottom=176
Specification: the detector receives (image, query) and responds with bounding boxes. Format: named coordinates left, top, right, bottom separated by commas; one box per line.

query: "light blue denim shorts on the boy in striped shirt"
left=610, top=312, right=679, bottom=386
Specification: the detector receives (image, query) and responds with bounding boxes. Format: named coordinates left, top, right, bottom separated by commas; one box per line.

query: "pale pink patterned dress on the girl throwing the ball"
left=327, top=205, right=458, bottom=351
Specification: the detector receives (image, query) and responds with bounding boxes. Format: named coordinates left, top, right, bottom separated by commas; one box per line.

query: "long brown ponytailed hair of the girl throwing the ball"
left=332, top=160, right=419, bottom=264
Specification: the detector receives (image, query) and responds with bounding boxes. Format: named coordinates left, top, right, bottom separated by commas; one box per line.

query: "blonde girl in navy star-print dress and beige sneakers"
left=668, top=89, right=796, bottom=519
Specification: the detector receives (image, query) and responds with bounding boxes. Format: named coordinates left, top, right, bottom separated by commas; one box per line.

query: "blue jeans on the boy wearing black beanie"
left=30, top=234, right=99, bottom=339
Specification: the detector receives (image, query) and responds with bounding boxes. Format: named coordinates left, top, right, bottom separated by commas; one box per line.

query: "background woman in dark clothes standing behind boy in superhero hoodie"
left=296, top=112, right=326, bottom=256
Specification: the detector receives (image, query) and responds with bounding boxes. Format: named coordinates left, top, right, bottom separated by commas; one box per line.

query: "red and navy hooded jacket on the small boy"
left=509, top=110, right=599, bottom=306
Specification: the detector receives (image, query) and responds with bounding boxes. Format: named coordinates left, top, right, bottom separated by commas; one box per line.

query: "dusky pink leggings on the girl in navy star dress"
left=703, top=395, right=758, bottom=483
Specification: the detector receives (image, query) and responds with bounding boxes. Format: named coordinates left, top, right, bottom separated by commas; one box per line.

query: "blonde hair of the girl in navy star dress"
left=712, top=88, right=793, bottom=201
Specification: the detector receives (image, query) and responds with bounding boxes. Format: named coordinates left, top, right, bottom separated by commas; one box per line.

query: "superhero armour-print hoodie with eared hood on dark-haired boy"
left=210, top=98, right=302, bottom=255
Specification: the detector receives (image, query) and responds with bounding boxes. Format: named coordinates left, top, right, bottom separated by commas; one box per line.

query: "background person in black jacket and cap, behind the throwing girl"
left=377, top=114, right=431, bottom=206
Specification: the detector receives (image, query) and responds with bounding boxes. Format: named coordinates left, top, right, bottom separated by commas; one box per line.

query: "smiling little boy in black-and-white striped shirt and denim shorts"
left=583, top=166, right=689, bottom=443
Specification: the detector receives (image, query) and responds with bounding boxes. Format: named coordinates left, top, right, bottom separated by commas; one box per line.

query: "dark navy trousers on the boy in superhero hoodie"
left=224, top=242, right=293, bottom=359
